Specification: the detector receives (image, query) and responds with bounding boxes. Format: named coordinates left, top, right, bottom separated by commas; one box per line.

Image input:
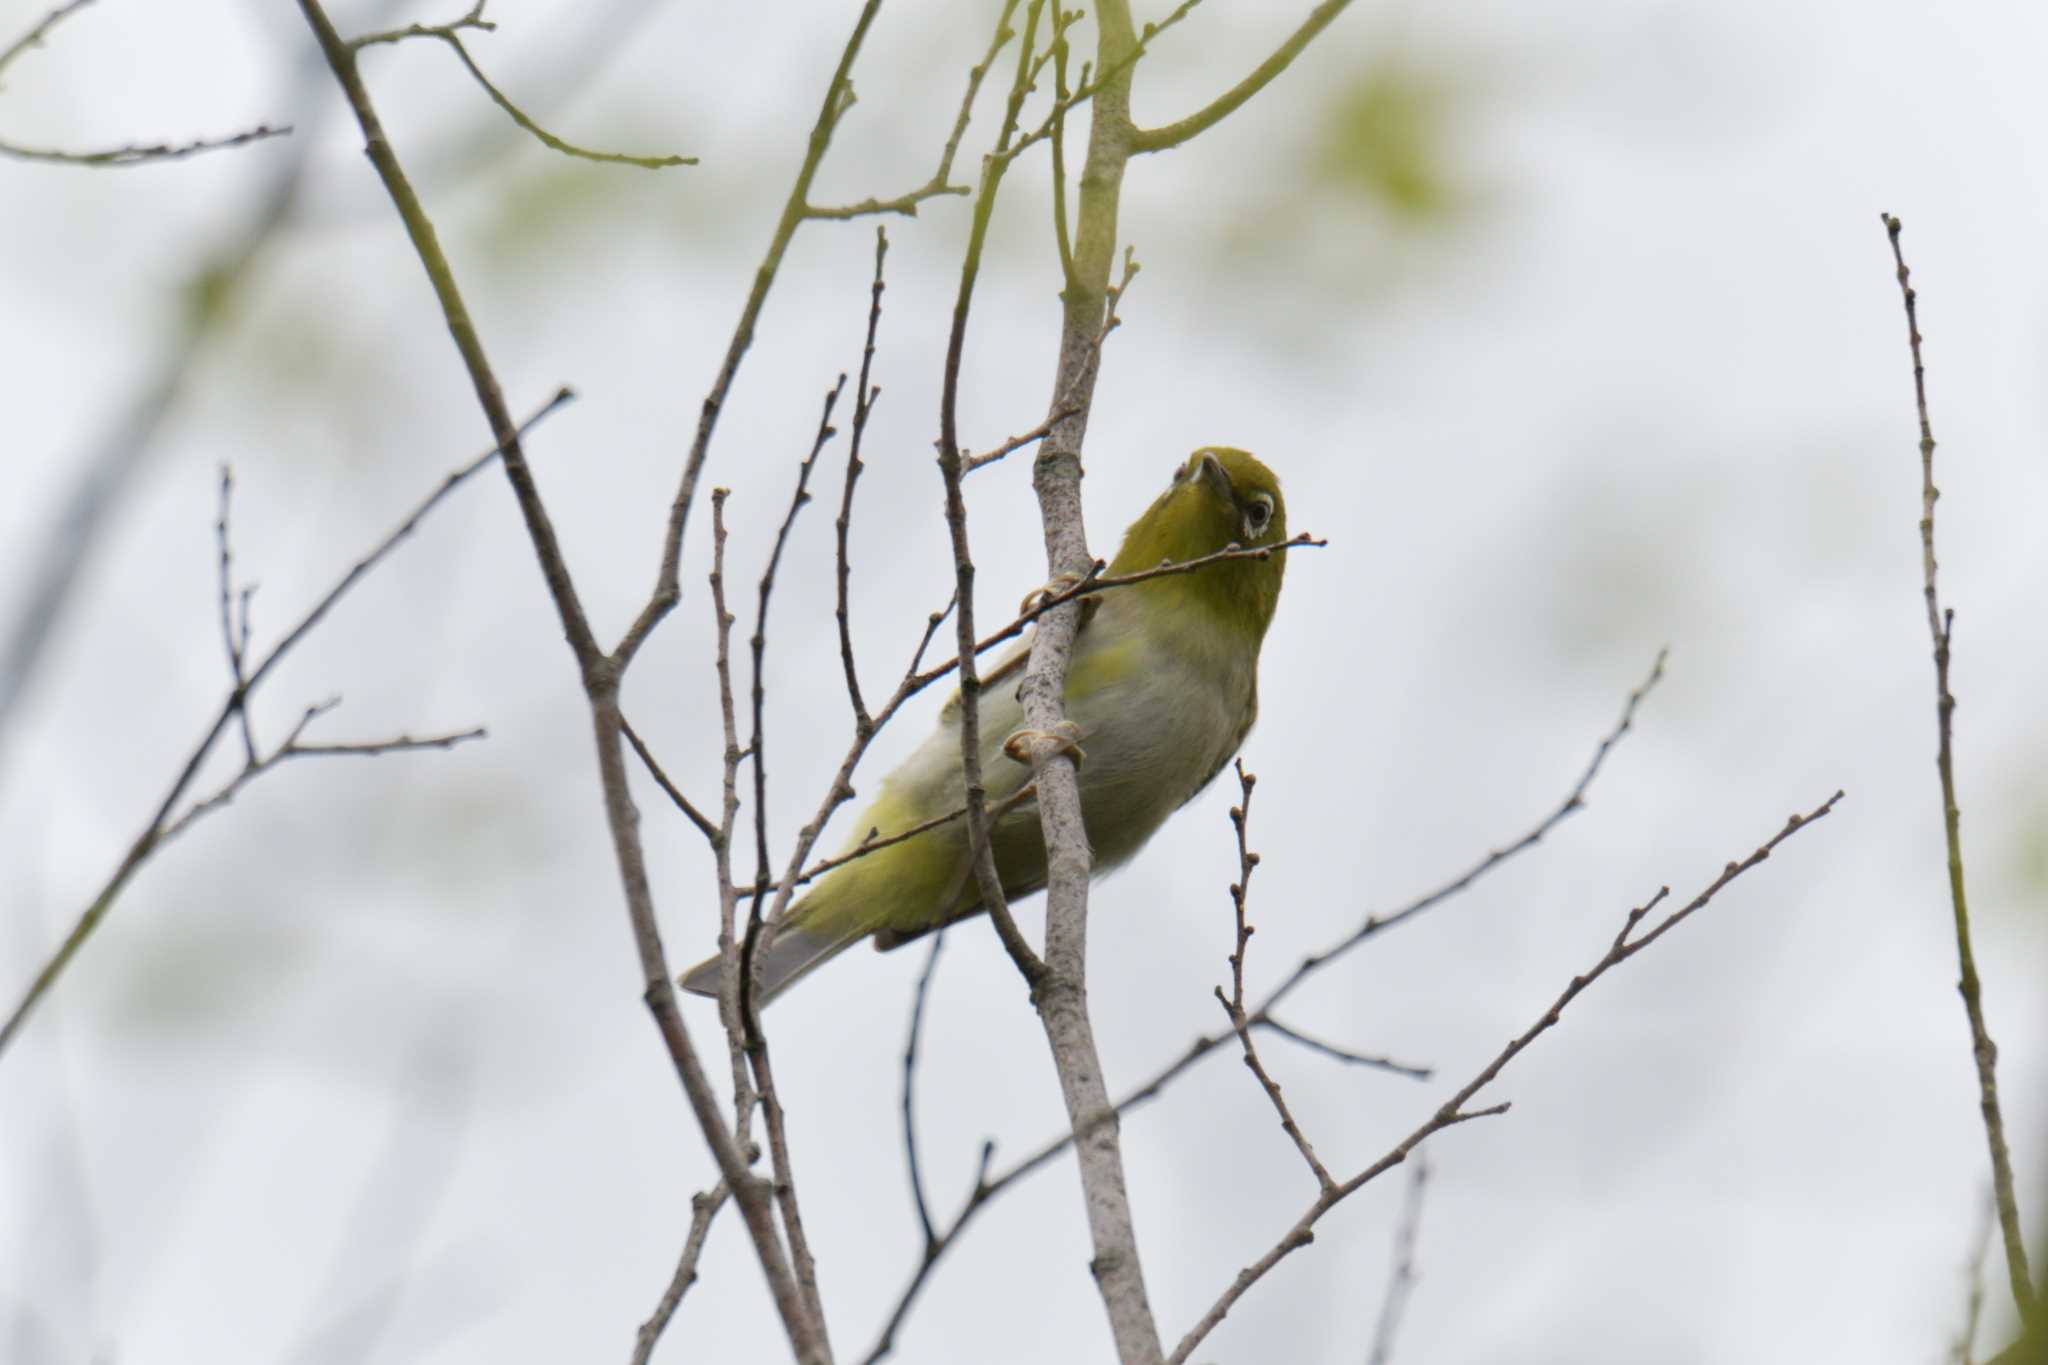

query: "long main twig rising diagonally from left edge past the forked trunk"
left=0, top=389, right=575, bottom=1056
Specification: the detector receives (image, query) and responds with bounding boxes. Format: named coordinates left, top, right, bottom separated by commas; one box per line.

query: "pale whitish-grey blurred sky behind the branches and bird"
left=0, top=0, right=2048, bottom=1365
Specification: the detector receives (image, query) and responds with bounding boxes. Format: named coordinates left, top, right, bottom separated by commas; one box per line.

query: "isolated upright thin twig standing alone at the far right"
left=1882, top=213, right=2034, bottom=1324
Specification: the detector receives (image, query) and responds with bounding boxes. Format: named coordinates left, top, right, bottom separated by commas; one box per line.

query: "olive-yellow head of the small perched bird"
left=1110, top=446, right=1286, bottom=647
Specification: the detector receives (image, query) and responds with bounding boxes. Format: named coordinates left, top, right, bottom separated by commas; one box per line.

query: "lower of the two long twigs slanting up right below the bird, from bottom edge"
left=1167, top=792, right=1841, bottom=1365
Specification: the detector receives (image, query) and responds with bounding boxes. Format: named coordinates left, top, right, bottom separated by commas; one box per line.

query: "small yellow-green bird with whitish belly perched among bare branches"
left=682, top=446, right=1288, bottom=1005
